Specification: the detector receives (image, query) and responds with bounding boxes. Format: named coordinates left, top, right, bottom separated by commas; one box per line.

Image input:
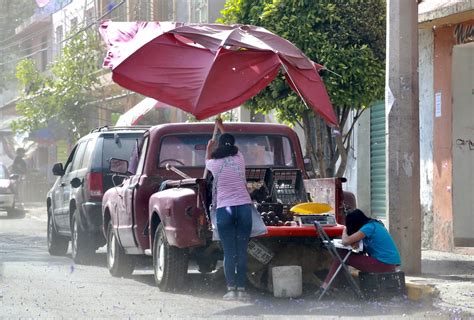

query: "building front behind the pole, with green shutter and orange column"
left=347, top=0, right=474, bottom=251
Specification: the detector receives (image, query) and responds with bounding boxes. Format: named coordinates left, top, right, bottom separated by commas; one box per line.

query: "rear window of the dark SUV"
left=102, top=133, right=141, bottom=170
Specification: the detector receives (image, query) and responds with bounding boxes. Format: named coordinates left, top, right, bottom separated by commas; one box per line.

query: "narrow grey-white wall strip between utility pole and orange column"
left=418, top=29, right=434, bottom=248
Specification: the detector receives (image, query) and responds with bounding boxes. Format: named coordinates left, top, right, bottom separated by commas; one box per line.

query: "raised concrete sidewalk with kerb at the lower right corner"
left=406, top=248, right=474, bottom=317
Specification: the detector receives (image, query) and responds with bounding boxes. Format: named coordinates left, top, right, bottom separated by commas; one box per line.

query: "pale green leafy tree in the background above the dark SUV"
left=12, top=32, right=100, bottom=141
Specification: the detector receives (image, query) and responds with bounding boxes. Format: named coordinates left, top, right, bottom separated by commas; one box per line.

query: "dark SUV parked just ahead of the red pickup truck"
left=46, top=127, right=146, bottom=263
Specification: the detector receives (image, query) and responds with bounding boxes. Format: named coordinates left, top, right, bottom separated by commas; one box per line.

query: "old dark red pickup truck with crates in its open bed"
left=102, top=123, right=356, bottom=290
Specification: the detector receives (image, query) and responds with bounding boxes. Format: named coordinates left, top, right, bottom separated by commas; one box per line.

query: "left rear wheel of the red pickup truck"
left=153, top=224, right=188, bottom=291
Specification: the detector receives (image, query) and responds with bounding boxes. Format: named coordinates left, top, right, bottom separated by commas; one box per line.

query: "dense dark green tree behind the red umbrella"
left=220, top=0, right=385, bottom=177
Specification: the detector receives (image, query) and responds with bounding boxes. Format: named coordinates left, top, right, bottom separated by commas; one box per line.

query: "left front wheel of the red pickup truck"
left=107, top=222, right=134, bottom=277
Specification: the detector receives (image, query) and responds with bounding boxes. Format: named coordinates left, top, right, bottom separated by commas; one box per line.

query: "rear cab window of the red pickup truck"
left=158, top=134, right=295, bottom=168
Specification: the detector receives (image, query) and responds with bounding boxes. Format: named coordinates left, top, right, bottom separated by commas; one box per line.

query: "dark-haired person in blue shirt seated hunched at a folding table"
left=321, top=209, right=401, bottom=289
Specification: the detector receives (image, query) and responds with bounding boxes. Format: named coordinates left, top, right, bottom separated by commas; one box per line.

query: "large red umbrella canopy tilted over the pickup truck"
left=100, top=21, right=337, bottom=125
